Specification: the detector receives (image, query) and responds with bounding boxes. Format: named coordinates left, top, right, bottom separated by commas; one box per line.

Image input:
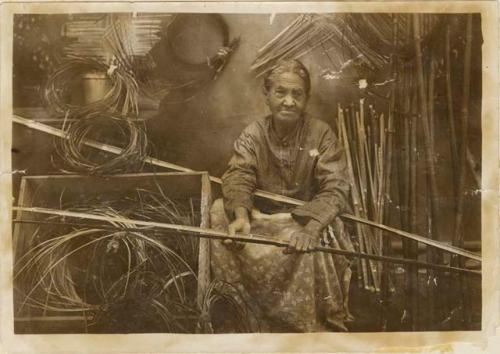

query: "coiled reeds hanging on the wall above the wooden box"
left=44, top=15, right=158, bottom=174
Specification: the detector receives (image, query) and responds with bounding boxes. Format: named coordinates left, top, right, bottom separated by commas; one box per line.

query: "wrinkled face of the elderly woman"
left=266, top=73, right=308, bottom=124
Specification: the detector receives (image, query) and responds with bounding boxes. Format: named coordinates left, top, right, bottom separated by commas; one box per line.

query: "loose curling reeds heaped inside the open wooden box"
left=15, top=189, right=198, bottom=331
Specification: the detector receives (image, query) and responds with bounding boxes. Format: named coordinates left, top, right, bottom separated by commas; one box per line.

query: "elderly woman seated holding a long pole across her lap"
left=211, top=60, right=352, bottom=332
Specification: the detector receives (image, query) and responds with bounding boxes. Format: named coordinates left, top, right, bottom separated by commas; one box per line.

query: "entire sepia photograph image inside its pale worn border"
left=3, top=0, right=498, bottom=352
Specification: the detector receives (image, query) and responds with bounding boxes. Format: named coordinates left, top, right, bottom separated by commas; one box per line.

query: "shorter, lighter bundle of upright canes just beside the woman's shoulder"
left=337, top=99, right=390, bottom=291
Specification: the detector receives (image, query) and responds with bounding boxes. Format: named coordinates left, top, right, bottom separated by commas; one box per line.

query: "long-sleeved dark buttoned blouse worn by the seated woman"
left=222, top=116, right=349, bottom=226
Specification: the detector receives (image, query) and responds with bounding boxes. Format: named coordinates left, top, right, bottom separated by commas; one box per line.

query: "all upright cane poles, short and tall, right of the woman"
left=338, top=15, right=478, bottom=330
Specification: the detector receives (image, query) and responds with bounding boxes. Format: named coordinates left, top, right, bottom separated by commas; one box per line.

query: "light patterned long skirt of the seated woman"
left=210, top=199, right=353, bottom=332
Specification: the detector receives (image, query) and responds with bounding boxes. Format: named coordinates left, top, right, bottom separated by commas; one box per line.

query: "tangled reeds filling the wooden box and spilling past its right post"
left=14, top=186, right=252, bottom=333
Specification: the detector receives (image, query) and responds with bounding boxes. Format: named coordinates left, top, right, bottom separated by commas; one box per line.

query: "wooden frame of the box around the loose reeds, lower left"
left=12, top=172, right=212, bottom=333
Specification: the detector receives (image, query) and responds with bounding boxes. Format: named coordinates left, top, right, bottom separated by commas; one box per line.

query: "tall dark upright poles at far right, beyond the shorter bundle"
left=396, top=14, right=472, bottom=330
